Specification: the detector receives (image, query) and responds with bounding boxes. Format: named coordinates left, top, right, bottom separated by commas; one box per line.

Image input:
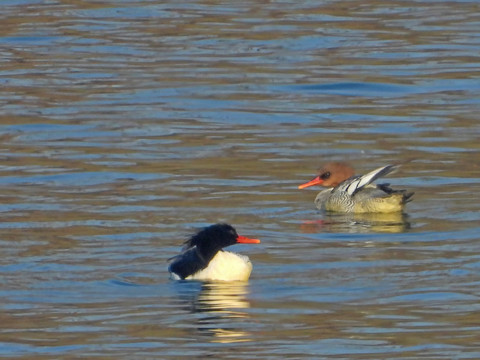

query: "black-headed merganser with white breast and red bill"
left=168, top=224, right=260, bottom=281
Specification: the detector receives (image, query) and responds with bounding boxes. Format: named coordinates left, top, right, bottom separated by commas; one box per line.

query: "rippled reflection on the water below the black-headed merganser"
left=176, top=281, right=252, bottom=343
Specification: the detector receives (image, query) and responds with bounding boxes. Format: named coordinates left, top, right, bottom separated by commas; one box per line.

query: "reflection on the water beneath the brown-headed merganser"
left=301, top=212, right=410, bottom=233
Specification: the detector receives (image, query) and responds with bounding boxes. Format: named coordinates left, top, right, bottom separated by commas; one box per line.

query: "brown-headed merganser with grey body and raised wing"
left=298, top=162, right=413, bottom=213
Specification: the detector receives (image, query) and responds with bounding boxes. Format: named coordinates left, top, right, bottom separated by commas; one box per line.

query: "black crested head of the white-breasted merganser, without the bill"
left=185, top=224, right=242, bottom=256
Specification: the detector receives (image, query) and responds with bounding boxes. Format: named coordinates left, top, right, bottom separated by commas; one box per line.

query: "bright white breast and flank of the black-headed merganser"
left=186, top=251, right=252, bottom=281
